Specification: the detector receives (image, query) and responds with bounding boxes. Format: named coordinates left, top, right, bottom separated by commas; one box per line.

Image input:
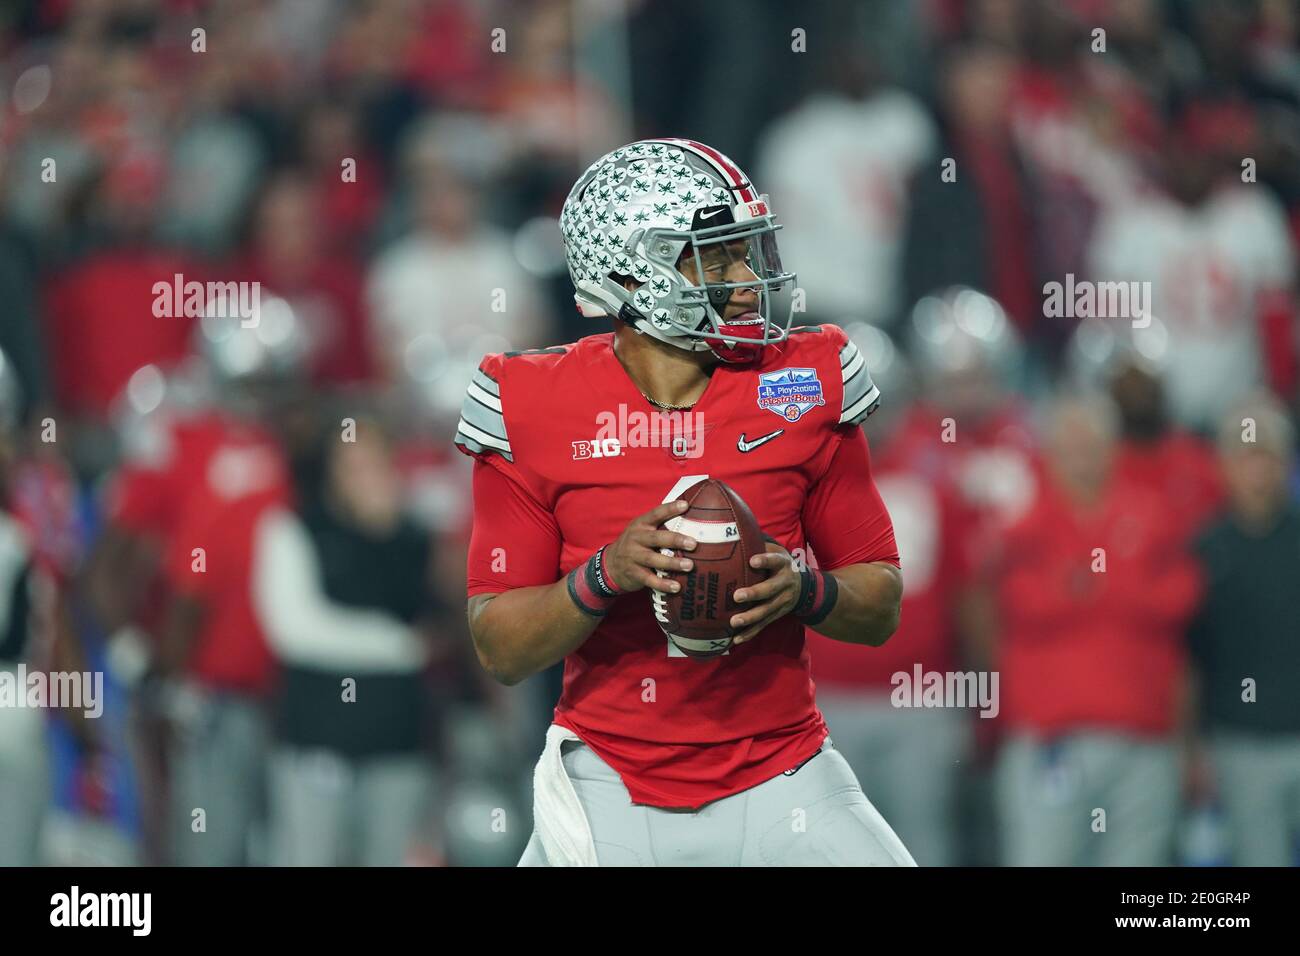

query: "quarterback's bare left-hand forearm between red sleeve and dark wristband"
left=469, top=579, right=599, bottom=684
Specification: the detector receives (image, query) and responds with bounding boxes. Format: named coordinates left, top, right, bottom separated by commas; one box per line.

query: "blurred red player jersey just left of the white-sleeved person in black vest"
left=165, top=416, right=291, bottom=693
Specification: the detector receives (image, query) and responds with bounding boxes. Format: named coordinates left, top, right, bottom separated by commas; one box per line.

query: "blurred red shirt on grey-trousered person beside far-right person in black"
left=998, top=480, right=1200, bottom=735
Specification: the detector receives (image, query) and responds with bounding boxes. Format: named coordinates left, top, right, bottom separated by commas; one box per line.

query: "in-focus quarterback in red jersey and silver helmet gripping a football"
left=455, top=139, right=914, bottom=866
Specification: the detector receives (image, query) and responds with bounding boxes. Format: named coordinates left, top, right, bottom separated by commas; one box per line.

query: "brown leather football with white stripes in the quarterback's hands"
left=651, top=479, right=767, bottom=657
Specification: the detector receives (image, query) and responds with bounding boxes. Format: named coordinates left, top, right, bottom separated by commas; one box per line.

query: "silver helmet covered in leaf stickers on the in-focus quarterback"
left=560, top=139, right=794, bottom=362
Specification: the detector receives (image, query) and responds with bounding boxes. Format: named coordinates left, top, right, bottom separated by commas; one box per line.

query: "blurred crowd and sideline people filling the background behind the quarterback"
left=0, top=0, right=1300, bottom=865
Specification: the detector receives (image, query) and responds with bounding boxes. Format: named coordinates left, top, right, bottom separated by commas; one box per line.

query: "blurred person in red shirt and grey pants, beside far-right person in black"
left=997, top=398, right=1200, bottom=866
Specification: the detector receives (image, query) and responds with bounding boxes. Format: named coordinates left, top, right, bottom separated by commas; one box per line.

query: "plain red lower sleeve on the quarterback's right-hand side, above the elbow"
left=803, top=428, right=898, bottom=571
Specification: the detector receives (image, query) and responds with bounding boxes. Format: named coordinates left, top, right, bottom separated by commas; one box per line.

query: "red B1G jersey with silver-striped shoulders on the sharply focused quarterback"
left=456, top=325, right=898, bottom=808
